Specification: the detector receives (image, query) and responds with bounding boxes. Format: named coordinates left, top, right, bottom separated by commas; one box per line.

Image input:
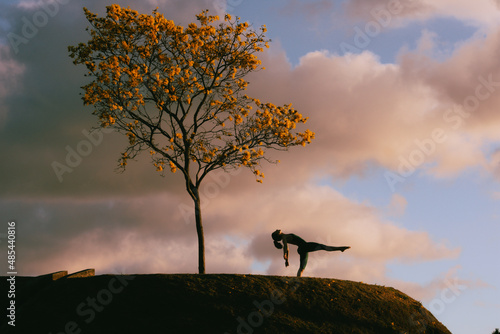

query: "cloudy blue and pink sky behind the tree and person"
left=0, top=0, right=500, bottom=334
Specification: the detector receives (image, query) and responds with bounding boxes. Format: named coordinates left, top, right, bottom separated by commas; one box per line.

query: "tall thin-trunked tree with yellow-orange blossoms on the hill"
left=68, top=5, right=314, bottom=273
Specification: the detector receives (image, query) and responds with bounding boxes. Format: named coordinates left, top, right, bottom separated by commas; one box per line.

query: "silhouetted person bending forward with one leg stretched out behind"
left=271, top=230, right=351, bottom=277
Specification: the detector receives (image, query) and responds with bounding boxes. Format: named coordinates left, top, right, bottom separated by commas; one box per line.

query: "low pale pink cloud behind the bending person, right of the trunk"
left=232, top=185, right=460, bottom=280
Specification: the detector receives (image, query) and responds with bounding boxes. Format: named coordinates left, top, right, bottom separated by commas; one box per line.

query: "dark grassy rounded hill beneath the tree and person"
left=0, top=274, right=450, bottom=334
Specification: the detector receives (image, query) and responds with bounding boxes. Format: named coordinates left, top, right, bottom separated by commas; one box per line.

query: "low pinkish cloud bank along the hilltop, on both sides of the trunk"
left=0, top=180, right=460, bottom=282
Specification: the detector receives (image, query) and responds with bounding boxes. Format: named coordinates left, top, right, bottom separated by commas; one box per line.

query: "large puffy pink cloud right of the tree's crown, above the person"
left=248, top=52, right=435, bottom=175
